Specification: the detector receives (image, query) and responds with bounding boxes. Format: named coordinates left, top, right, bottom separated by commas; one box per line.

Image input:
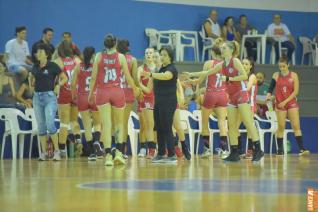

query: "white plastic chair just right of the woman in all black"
left=180, top=110, right=201, bottom=155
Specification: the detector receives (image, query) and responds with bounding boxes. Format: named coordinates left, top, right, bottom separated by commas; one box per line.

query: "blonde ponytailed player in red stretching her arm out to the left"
left=199, top=41, right=264, bottom=162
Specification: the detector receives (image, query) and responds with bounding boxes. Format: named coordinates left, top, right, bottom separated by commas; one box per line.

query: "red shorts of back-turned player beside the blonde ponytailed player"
left=202, top=90, right=229, bottom=109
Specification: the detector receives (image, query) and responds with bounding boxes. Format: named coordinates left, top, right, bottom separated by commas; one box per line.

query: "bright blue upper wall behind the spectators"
left=0, top=0, right=318, bottom=61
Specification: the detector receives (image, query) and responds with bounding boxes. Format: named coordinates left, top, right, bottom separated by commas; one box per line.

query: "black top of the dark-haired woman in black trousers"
left=153, top=64, right=178, bottom=99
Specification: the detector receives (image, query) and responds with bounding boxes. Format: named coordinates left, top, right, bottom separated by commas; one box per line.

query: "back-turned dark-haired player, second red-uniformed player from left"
left=72, top=46, right=103, bottom=161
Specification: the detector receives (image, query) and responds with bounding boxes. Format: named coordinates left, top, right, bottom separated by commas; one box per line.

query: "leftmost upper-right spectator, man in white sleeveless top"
left=203, top=10, right=221, bottom=39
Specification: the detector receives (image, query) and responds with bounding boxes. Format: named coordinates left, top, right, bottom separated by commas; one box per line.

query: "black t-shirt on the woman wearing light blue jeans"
left=32, top=62, right=62, bottom=92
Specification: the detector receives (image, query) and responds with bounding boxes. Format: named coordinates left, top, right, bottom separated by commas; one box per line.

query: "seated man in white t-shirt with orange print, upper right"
left=267, top=14, right=296, bottom=61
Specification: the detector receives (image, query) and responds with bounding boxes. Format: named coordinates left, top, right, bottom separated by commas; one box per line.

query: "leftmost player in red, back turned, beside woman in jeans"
left=55, top=40, right=81, bottom=158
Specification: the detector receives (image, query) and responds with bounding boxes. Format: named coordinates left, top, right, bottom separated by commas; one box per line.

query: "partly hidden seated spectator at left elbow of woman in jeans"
left=17, top=76, right=34, bottom=108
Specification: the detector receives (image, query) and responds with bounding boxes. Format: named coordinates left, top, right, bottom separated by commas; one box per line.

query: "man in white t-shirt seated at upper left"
left=5, top=26, right=33, bottom=79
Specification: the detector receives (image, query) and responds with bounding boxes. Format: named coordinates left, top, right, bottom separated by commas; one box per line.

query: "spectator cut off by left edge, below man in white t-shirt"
left=0, top=62, right=16, bottom=104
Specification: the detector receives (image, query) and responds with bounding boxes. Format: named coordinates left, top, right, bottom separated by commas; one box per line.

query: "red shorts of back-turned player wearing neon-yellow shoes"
left=96, top=87, right=125, bottom=108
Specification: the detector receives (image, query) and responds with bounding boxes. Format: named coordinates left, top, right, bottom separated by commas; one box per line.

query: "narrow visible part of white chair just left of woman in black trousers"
left=128, top=111, right=140, bottom=156
